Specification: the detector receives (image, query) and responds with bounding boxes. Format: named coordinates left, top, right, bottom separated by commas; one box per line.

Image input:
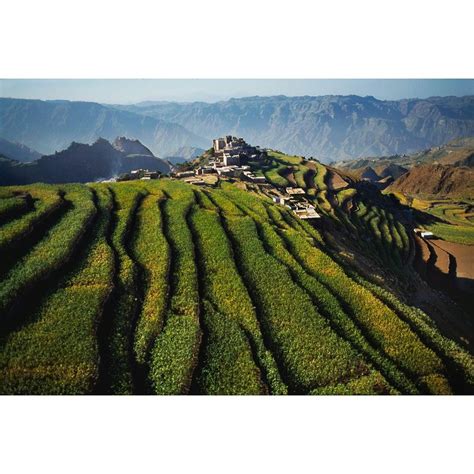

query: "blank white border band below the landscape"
left=0, top=397, right=474, bottom=474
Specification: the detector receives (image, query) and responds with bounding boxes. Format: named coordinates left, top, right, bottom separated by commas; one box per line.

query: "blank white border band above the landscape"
left=0, top=0, right=474, bottom=78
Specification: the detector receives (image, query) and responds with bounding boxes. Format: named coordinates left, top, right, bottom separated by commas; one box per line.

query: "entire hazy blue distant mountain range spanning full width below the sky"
left=0, top=95, right=474, bottom=163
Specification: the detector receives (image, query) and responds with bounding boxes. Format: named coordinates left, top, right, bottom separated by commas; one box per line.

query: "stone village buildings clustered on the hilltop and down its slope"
left=174, top=135, right=320, bottom=219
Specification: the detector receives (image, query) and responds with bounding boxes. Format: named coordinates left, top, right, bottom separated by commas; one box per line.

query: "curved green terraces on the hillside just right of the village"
left=241, top=152, right=413, bottom=272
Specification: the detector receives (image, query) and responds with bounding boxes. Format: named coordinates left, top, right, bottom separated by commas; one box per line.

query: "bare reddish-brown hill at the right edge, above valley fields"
left=388, top=165, right=474, bottom=199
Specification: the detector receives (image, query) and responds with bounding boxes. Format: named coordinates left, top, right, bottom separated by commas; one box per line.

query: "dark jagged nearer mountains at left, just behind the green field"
left=0, top=137, right=171, bottom=185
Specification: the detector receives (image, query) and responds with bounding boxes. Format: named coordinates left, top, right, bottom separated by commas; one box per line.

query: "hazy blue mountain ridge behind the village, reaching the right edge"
left=115, top=96, right=474, bottom=162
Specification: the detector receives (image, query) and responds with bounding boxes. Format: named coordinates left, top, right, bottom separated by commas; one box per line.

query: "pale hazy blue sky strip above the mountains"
left=0, top=79, right=474, bottom=104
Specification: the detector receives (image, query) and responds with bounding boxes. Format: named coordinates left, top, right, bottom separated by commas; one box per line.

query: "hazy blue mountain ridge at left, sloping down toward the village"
left=0, top=98, right=208, bottom=156
